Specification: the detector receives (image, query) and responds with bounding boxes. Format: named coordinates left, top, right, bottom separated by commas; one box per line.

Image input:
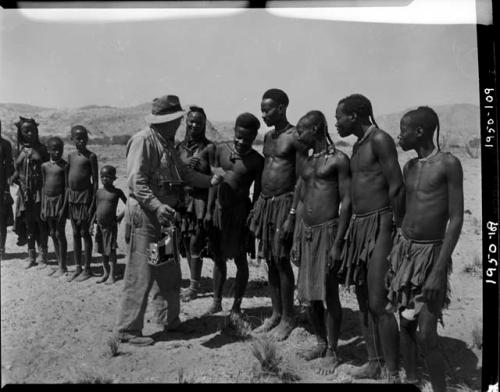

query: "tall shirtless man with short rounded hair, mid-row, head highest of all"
left=250, top=89, right=305, bottom=340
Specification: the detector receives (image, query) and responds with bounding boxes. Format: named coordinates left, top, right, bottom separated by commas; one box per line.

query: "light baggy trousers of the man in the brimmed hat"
left=115, top=198, right=182, bottom=336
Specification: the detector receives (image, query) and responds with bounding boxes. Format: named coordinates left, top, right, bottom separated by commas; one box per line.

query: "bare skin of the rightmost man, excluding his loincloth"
left=399, top=117, right=464, bottom=391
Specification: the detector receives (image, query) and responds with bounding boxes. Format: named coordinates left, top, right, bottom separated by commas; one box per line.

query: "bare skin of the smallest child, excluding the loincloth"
left=91, top=172, right=127, bottom=284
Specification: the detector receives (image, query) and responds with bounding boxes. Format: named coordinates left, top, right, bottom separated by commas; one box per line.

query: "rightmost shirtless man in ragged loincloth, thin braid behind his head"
left=387, top=106, right=464, bottom=392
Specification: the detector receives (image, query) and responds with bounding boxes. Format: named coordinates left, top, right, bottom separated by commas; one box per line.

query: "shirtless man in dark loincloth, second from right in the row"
left=335, top=94, right=404, bottom=382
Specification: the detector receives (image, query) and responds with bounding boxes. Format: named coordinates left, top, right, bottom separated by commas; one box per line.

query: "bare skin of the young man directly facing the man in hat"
left=204, top=127, right=264, bottom=316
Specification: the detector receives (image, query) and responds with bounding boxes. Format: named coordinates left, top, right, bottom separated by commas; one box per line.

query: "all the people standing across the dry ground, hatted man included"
left=0, top=89, right=463, bottom=391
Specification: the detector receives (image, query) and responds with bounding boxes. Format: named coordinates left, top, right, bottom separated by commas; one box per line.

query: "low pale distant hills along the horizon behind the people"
left=0, top=103, right=480, bottom=145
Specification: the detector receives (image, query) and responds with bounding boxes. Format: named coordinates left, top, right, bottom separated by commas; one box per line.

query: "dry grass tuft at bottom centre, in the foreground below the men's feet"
left=252, top=337, right=300, bottom=383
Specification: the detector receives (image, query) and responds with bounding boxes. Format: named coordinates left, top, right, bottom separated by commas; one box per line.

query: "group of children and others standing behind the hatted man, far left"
left=0, top=117, right=126, bottom=283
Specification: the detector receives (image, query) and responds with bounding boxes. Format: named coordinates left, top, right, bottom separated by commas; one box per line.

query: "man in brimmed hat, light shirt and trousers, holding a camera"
left=115, top=95, right=222, bottom=346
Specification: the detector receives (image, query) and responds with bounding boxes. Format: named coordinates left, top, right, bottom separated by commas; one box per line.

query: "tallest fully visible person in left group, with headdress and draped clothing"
left=12, top=117, right=49, bottom=268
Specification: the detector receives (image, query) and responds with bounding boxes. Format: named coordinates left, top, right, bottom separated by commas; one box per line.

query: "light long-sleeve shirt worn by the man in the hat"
left=127, top=128, right=211, bottom=212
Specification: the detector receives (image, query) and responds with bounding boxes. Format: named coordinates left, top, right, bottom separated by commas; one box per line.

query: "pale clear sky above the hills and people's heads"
left=0, top=9, right=479, bottom=122
